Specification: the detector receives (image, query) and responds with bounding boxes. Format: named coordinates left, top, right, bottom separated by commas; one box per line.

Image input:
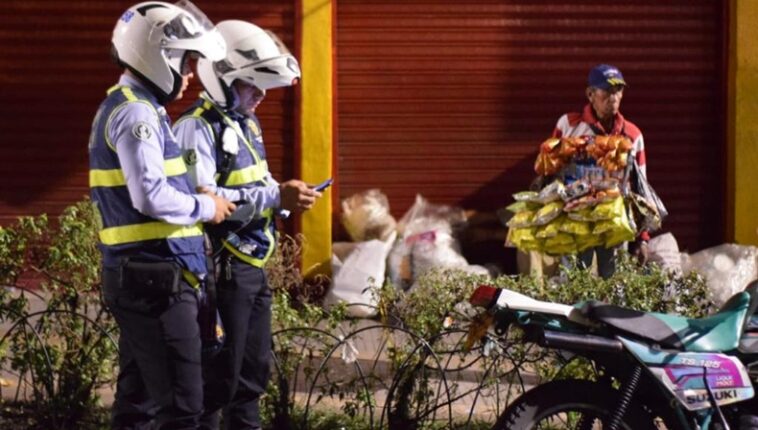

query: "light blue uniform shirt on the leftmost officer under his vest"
left=106, top=74, right=216, bottom=225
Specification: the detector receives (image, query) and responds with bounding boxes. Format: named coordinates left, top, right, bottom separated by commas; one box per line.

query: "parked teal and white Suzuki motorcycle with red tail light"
left=469, top=281, right=758, bottom=430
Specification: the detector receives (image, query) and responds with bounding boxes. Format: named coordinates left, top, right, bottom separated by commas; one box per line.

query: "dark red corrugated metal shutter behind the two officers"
left=0, top=0, right=295, bottom=224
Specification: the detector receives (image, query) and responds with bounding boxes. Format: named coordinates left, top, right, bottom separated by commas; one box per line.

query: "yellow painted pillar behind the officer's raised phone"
left=300, top=0, right=334, bottom=276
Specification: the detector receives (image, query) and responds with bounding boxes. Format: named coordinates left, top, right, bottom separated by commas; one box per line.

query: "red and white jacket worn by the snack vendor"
left=553, top=104, right=649, bottom=240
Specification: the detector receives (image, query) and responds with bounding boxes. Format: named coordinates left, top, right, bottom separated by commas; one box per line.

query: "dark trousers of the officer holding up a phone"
left=201, top=258, right=271, bottom=430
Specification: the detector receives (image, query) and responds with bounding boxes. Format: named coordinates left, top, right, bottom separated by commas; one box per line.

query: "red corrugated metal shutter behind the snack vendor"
left=337, top=0, right=725, bottom=254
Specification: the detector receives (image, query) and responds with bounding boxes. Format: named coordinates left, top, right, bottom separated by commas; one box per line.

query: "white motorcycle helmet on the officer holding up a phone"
left=197, top=20, right=300, bottom=109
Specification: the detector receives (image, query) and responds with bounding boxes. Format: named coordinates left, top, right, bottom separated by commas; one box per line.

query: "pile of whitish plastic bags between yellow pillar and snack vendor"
left=325, top=189, right=489, bottom=317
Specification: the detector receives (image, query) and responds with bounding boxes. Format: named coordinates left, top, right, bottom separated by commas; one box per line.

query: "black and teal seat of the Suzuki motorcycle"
left=579, top=288, right=756, bottom=352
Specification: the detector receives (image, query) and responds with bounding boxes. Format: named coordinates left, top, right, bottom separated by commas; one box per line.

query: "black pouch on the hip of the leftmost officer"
left=121, top=258, right=182, bottom=296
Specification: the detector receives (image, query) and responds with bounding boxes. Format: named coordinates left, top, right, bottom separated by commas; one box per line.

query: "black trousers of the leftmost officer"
left=102, top=268, right=203, bottom=430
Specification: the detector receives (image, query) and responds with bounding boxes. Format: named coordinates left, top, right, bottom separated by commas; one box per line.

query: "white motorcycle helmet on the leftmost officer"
left=111, top=0, right=226, bottom=102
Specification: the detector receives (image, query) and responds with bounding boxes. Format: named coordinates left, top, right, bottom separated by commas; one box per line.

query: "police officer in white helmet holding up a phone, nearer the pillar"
left=174, top=20, right=321, bottom=430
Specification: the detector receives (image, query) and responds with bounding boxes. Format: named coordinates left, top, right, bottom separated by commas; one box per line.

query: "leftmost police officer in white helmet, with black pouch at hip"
left=89, top=2, right=235, bottom=429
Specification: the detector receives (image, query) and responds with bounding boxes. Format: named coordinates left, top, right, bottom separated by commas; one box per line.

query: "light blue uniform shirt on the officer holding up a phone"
left=174, top=94, right=280, bottom=218
